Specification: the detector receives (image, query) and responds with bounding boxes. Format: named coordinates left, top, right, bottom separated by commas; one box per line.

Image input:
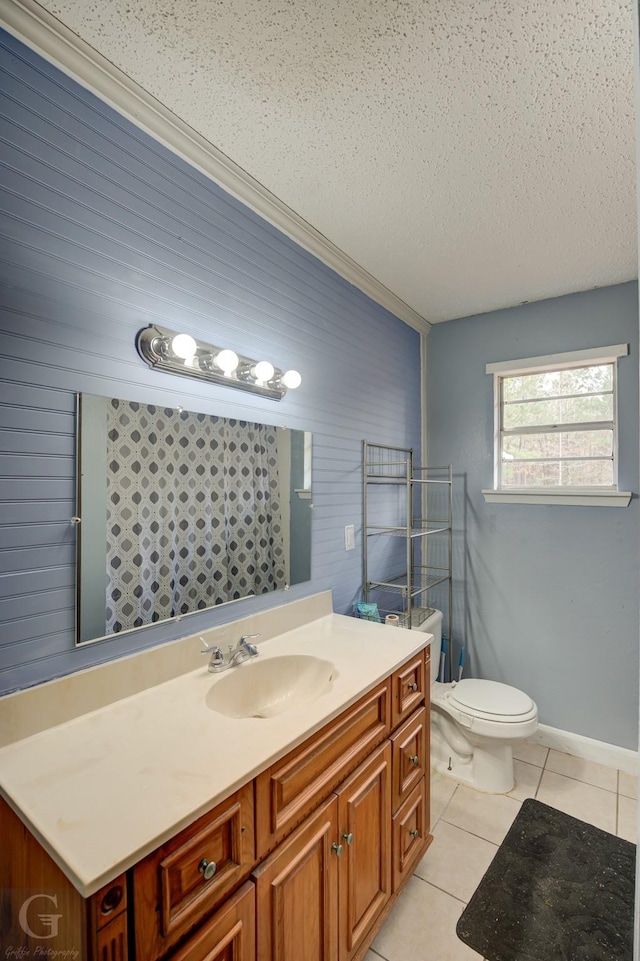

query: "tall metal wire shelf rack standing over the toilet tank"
left=362, top=440, right=453, bottom=670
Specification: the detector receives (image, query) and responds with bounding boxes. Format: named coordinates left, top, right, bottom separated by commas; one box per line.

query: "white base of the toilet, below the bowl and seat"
left=431, top=719, right=515, bottom=794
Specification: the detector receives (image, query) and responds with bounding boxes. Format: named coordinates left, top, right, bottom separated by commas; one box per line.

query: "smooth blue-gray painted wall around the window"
left=427, top=283, right=639, bottom=749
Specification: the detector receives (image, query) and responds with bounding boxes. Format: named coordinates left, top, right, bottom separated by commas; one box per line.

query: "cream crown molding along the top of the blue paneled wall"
left=0, top=0, right=431, bottom=334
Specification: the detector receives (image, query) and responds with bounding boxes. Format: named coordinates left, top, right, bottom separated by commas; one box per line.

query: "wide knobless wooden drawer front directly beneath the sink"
left=255, top=681, right=391, bottom=858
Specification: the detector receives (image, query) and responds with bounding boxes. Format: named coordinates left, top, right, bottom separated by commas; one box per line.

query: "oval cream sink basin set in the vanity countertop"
left=206, top=654, right=338, bottom=717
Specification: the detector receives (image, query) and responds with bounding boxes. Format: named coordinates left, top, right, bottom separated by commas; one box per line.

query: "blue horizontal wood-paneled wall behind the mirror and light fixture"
left=0, top=32, right=420, bottom=693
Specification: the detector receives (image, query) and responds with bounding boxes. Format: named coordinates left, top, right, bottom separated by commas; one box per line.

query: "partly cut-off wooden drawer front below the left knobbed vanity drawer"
left=171, top=881, right=256, bottom=961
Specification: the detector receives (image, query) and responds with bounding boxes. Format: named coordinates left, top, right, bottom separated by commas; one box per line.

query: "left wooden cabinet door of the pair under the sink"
left=253, top=796, right=338, bottom=961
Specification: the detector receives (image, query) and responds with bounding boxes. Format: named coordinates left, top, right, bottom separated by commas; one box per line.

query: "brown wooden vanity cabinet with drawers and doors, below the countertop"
left=0, top=640, right=431, bottom=961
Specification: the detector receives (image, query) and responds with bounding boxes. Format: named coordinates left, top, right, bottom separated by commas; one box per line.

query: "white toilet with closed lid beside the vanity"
left=414, top=611, right=538, bottom=794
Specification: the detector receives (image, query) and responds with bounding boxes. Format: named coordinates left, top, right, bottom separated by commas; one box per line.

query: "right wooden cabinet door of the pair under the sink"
left=337, top=741, right=391, bottom=961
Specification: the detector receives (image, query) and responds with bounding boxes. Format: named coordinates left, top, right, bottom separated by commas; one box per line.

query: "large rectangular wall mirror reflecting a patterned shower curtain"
left=75, top=394, right=312, bottom=644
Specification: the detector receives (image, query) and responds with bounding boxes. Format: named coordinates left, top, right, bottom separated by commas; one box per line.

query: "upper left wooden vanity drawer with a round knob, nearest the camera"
left=133, top=783, right=255, bottom=961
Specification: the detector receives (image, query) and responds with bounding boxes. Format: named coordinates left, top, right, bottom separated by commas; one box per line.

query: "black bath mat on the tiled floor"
left=456, top=799, right=636, bottom=961
